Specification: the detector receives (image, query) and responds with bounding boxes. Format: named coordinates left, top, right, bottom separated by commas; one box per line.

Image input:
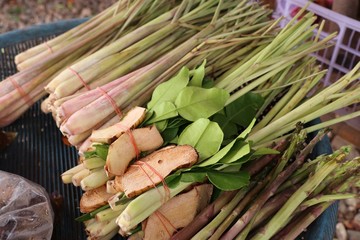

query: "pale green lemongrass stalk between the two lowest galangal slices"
left=116, top=182, right=192, bottom=232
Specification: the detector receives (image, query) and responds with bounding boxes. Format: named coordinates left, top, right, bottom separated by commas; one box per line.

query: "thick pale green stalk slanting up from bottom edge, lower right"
left=249, top=149, right=346, bottom=240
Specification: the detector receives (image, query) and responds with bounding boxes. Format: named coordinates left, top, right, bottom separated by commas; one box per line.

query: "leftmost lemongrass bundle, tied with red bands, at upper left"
left=0, top=0, right=180, bottom=126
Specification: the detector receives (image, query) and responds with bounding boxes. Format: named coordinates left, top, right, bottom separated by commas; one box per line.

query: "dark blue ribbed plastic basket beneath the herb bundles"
left=0, top=19, right=337, bottom=240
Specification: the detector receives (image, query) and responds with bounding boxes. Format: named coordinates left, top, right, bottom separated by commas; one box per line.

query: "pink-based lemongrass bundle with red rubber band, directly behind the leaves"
left=49, top=1, right=273, bottom=149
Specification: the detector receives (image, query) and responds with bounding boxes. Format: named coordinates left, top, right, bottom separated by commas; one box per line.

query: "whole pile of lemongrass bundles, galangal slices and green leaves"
left=0, top=0, right=360, bottom=239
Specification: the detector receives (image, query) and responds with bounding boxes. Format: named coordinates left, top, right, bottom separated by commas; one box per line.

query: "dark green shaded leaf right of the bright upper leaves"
left=225, top=92, right=264, bottom=127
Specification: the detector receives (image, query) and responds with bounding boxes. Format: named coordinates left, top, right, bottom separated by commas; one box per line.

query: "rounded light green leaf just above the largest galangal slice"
left=178, top=118, right=224, bottom=161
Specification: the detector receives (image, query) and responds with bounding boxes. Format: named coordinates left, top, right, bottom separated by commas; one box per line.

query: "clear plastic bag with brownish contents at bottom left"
left=0, top=171, right=54, bottom=240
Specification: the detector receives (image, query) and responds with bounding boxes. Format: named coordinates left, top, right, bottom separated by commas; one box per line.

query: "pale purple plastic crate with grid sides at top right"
left=274, top=0, right=360, bottom=131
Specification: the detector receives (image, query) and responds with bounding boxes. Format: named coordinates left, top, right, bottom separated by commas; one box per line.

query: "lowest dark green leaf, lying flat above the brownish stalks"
left=207, top=171, right=250, bottom=191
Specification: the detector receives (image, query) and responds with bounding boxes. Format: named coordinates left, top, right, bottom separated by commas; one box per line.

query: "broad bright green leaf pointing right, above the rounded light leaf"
left=175, top=87, right=229, bottom=121
